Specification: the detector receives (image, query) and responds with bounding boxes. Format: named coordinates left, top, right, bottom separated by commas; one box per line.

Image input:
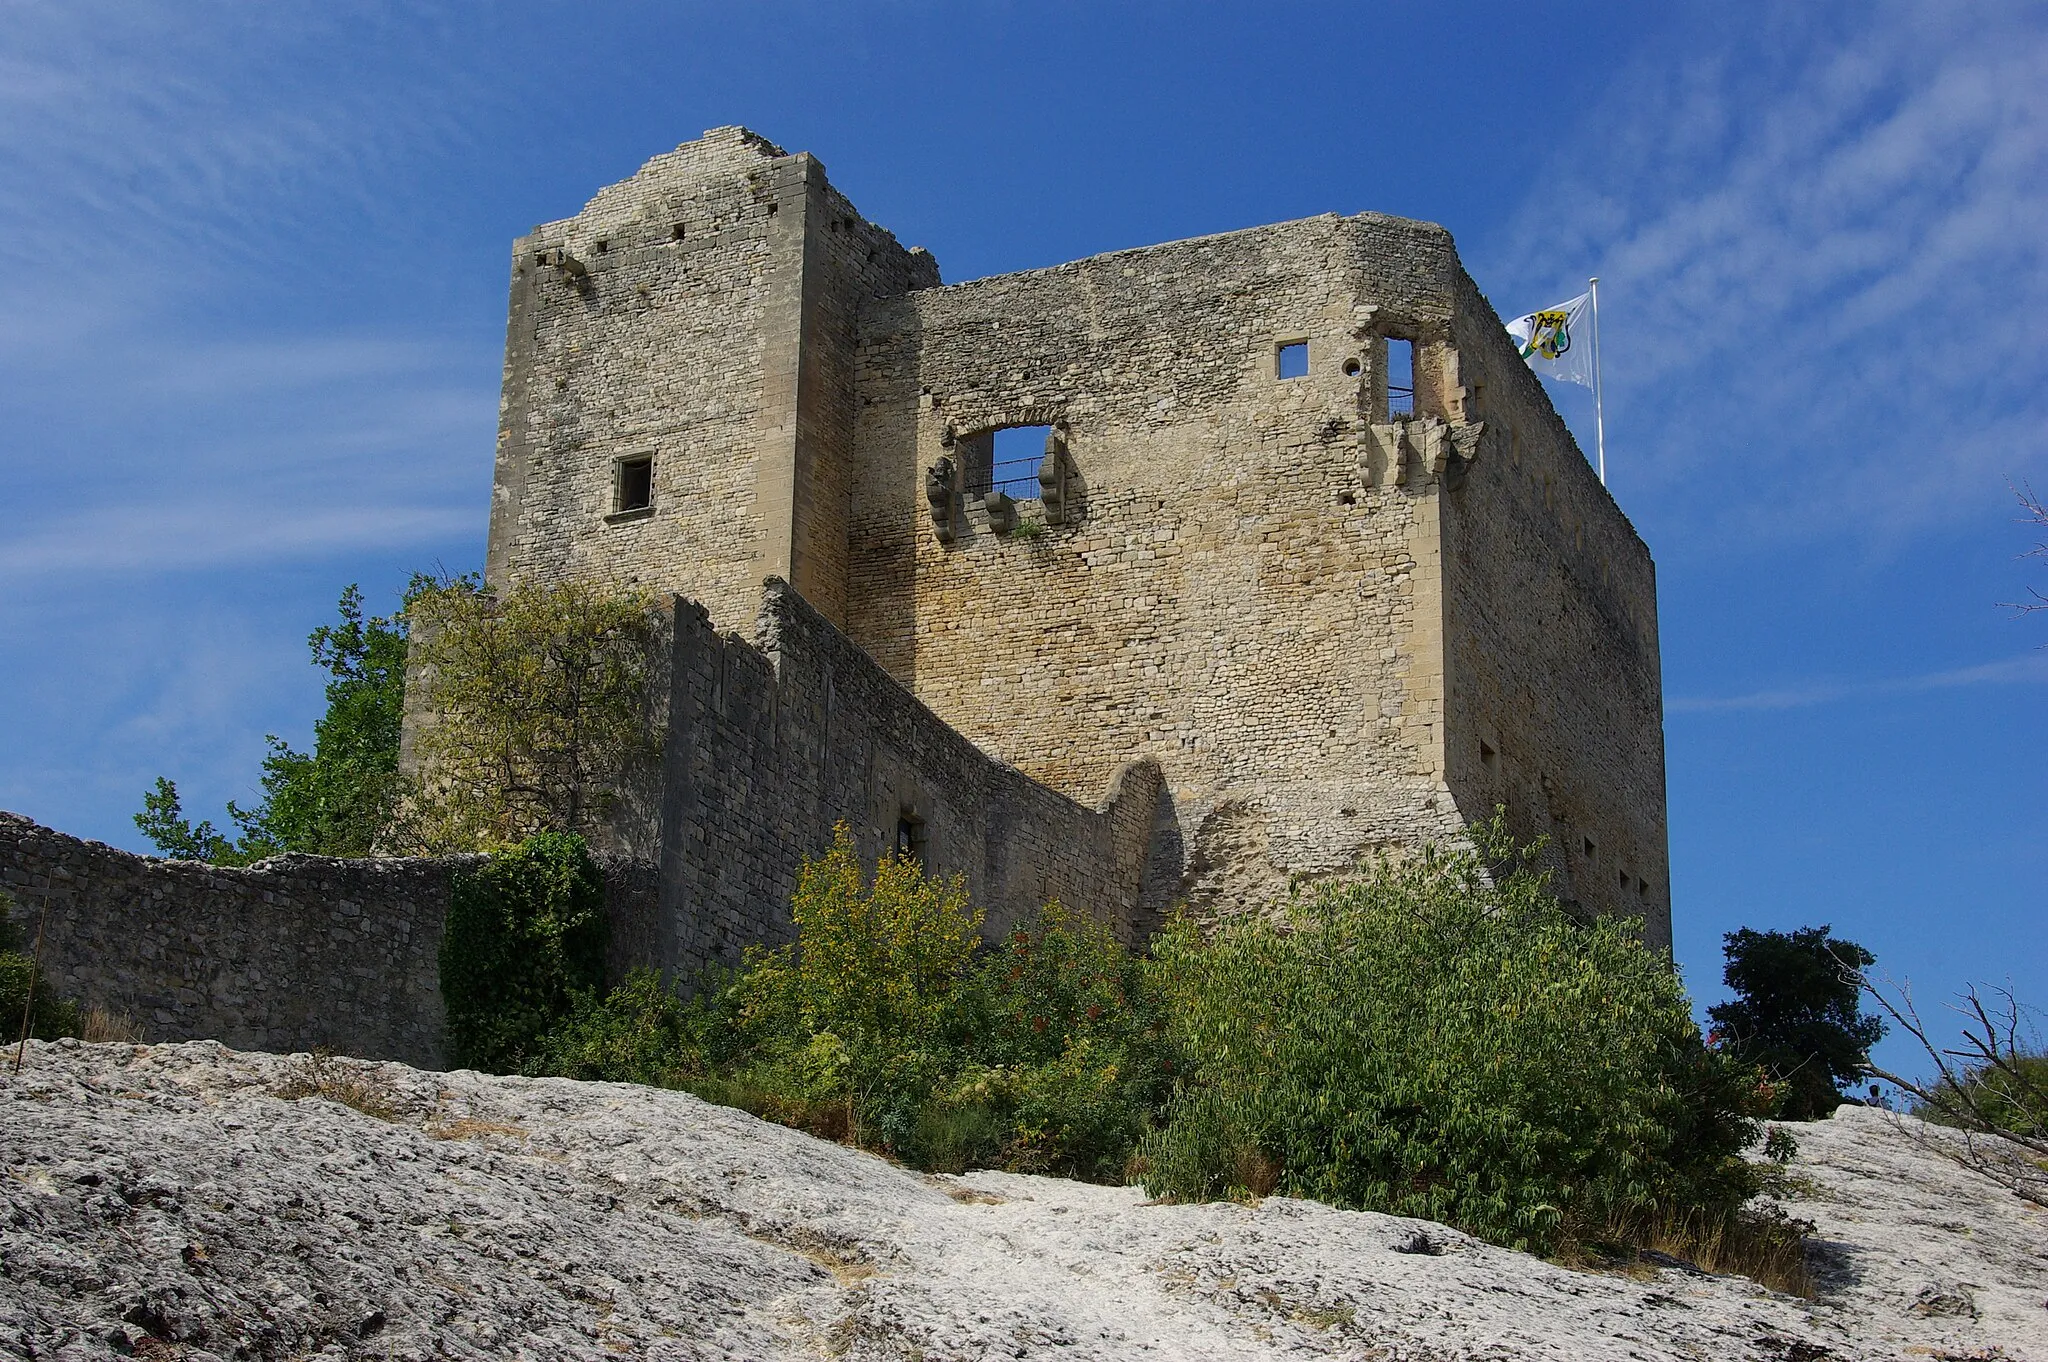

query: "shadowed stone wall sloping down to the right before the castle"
left=657, top=582, right=1161, bottom=963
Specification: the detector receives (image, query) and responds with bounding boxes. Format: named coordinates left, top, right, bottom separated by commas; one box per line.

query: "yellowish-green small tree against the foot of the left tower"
left=393, top=580, right=662, bottom=852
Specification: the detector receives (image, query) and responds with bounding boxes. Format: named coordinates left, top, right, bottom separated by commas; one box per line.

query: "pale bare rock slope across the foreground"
left=0, top=1040, right=2048, bottom=1362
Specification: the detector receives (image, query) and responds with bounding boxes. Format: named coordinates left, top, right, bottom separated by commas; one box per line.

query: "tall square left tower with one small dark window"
left=485, top=127, right=938, bottom=629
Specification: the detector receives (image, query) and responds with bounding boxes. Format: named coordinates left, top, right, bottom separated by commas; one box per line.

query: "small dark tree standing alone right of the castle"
left=1706, top=924, right=1884, bottom=1120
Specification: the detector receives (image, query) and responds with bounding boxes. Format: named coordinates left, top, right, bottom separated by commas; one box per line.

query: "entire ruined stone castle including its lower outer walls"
left=0, top=127, right=1671, bottom=1067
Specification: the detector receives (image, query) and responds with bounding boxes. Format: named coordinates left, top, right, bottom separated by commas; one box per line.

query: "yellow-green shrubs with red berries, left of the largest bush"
left=539, top=825, right=1169, bottom=1180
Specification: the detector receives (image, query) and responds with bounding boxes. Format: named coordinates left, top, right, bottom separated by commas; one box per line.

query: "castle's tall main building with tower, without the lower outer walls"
left=487, top=129, right=1669, bottom=942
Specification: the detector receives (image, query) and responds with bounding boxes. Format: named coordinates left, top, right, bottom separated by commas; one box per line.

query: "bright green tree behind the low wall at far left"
left=135, top=576, right=423, bottom=864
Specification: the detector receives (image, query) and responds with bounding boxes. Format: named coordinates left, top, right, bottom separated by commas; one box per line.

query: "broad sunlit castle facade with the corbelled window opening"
left=850, top=215, right=1460, bottom=903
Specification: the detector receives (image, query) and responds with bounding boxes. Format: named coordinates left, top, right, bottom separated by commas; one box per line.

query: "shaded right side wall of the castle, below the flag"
left=1444, top=270, right=1671, bottom=946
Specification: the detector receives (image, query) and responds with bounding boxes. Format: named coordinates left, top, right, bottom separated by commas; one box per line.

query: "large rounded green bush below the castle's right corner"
left=1143, top=825, right=1759, bottom=1251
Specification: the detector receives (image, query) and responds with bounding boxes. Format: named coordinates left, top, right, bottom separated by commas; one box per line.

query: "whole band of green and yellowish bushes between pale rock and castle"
left=516, top=827, right=1796, bottom=1253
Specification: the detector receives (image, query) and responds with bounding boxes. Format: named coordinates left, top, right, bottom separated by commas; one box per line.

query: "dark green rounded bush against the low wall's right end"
left=440, top=832, right=606, bottom=1073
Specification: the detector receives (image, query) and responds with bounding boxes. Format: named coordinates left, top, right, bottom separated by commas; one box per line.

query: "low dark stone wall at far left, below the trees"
left=0, top=813, right=655, bottom=1069
